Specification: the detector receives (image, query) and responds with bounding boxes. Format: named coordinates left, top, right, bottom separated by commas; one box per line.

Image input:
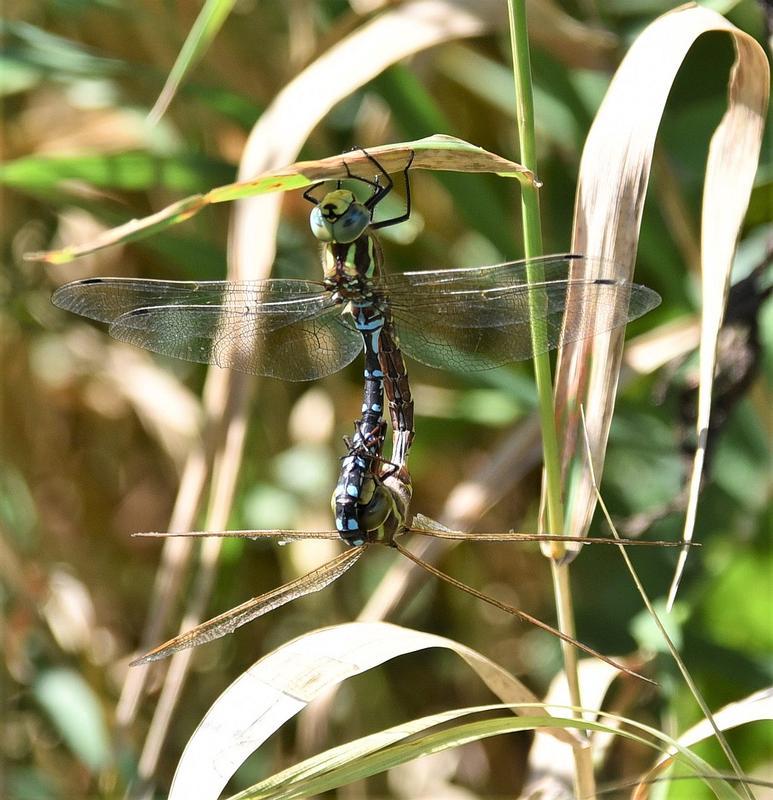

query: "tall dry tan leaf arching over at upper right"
left=556, top=5, right=769, bottom=580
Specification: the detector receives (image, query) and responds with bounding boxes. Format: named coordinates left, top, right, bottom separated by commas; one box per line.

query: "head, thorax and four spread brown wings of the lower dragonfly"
left=132, top=426, right=683, bottom=680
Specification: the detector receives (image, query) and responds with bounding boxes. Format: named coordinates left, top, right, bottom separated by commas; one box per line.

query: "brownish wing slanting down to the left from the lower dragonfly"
left=132, top=546, right=365, bottom=666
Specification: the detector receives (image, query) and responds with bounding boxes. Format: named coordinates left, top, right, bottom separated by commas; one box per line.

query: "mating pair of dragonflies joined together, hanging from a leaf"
left=53, top=151, right=660, bottom=663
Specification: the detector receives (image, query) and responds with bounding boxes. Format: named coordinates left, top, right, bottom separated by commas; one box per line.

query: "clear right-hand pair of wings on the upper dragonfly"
left=379, top=256, right=660, bottom=371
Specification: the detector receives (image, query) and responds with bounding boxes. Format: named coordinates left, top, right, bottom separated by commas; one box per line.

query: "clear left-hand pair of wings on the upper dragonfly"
left=53, top=278, right=362, bottom=380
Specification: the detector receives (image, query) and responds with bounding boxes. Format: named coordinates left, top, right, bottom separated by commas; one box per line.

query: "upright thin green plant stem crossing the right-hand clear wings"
left=508, top=0, right=595, bottom=798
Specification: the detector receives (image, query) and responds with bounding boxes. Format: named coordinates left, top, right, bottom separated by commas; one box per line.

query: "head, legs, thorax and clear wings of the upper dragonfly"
left=53, top=152, right=660, bottom=388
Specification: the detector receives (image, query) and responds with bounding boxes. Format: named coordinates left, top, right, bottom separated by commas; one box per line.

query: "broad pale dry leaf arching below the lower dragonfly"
left=164, top=622, right=577, bottom=800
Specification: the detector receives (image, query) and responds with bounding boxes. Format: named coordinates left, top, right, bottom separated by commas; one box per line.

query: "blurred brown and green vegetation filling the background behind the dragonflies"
left=0, top=0, right=773, bottom=800
